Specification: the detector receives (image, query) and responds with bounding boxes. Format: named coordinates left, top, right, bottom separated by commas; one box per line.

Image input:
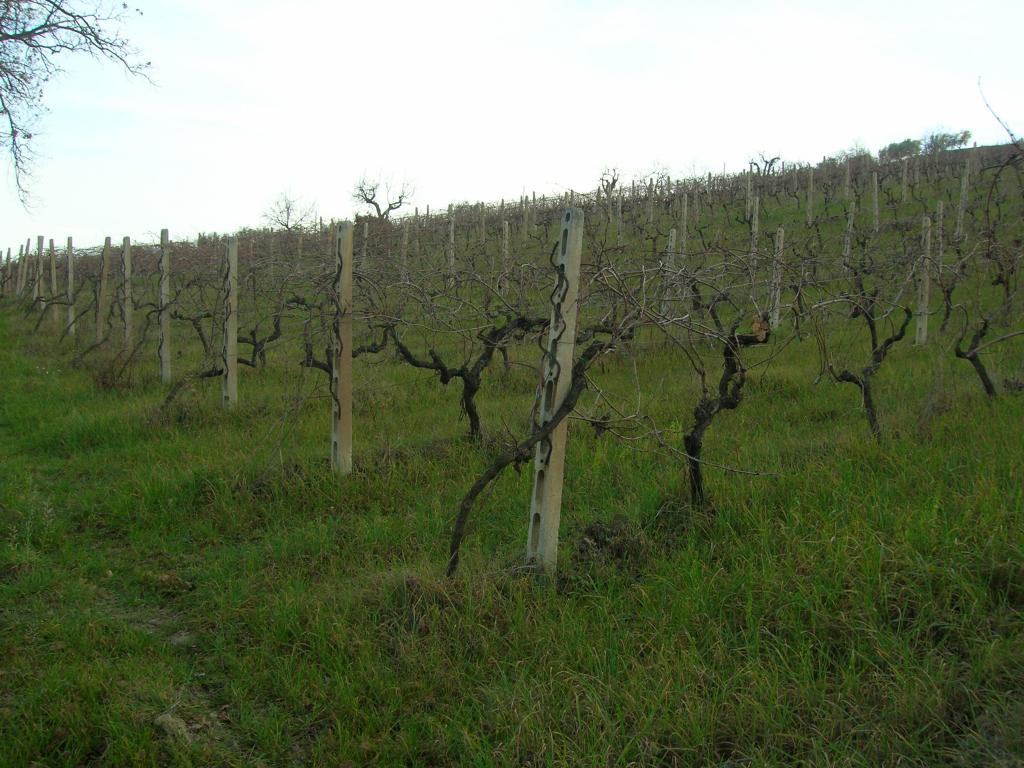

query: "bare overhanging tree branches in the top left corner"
left=0, top=0, right=150, bottom=203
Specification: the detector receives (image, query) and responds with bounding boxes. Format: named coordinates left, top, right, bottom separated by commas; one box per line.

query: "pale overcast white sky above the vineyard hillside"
left=0, top=0, right=1024, bottom=247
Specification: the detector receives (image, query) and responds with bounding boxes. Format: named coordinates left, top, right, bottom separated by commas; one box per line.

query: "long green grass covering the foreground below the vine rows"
left=0, top=290, right=1024, bottom=766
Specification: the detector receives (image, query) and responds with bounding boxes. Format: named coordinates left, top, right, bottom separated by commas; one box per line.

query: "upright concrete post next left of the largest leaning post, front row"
left=331, top=221, right=352, bottom=475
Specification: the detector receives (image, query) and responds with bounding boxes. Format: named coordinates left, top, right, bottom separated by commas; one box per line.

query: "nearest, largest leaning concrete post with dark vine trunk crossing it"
left=526, top=208, right=584, bottom=574
